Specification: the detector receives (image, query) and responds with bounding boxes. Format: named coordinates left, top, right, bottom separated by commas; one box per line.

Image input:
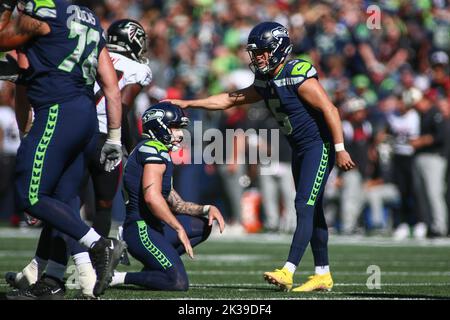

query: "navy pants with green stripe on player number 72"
left=15, top=96, right=98, bottom=240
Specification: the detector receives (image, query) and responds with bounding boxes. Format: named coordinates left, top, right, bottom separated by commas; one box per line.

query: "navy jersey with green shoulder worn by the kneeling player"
left=123, top=140, right=173, bottom=225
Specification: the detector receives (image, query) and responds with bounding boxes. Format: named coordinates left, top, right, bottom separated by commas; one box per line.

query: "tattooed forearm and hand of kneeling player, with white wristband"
left=167, top=189, right=225, bottom=233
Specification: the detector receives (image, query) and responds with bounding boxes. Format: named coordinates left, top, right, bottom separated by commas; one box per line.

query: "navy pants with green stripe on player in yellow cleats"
left=288, top=143, right=335, bottom=266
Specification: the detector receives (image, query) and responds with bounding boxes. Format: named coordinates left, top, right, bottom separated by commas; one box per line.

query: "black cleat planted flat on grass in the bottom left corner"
left=6, top=275, right=66, bottom=300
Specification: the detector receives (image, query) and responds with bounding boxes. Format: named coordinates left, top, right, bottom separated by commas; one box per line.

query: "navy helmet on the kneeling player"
left=142, top=102, right=189, bottom=149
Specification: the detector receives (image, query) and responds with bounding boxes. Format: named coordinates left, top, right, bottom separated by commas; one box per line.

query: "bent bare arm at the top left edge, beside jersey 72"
left=0, top=14, right=50, bottom=51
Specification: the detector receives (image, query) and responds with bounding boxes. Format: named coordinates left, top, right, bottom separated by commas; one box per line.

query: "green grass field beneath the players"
left=0, top=230, right=450, bottom=300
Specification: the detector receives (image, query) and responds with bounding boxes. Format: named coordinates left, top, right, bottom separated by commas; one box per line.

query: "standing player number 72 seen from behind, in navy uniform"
left=0, top=0, right=126, bottom=295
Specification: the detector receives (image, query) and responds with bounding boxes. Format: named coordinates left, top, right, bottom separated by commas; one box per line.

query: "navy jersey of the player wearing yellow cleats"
left=253, top=59, right=331, bottom=151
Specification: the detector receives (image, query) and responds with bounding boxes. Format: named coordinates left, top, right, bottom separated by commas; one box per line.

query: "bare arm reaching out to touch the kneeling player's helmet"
left=166, top=85, right=262, bottom=110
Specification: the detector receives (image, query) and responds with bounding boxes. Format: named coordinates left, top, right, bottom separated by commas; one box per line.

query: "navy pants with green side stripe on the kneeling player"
left=123, top=215, right=211, bottom=291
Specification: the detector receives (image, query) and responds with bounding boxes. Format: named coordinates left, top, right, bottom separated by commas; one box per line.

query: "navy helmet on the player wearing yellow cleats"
left=247, top=22, right=292, bottom=74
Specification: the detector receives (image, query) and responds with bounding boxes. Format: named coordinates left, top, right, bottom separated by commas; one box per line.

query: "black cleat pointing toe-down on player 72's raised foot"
left=89, top=238, right=127, bottom=297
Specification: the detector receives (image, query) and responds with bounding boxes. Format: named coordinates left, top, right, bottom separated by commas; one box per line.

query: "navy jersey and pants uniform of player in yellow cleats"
left=253, top=59, right=335, bottom=266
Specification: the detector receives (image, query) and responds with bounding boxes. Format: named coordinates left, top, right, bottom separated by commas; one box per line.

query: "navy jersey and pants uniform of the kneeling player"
left=123, top=140, right=211, bottom=290
